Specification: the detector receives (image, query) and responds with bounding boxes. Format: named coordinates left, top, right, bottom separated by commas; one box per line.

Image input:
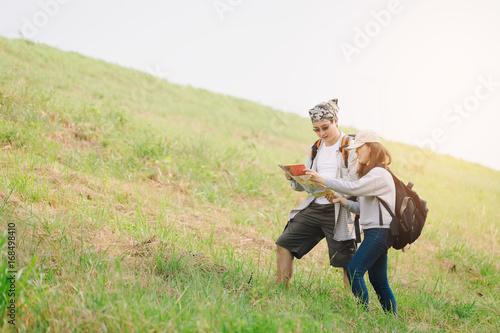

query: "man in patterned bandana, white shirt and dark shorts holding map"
left=276, top=99, right=358, bottom=290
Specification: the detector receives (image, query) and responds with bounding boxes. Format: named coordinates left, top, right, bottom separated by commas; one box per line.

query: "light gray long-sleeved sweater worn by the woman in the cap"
left=326, top=168, right=396, bottom=229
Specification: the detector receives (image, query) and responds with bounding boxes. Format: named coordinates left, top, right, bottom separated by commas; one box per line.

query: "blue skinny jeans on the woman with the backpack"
left=347, top=228, right=397, bottom=314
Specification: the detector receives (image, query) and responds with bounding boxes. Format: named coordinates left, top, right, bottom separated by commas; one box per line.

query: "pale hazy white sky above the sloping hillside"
left=0, top=0, right=500, bottom=170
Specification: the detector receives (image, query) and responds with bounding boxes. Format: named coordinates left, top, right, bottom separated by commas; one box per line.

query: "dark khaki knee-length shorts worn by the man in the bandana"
left=276, top=202, right=357, bottom=267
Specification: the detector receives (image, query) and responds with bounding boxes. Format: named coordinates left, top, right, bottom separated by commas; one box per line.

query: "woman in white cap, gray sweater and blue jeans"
left=305, top=130, right=397, bottom=314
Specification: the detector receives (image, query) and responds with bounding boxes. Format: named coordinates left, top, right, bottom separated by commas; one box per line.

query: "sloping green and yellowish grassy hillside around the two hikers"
left=0, top=38, right=500, bottom=332
